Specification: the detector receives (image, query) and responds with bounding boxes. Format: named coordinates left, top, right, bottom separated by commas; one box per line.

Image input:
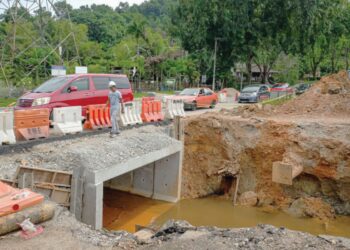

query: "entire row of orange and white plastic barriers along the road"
left=0, top=97, right=185, bottom=143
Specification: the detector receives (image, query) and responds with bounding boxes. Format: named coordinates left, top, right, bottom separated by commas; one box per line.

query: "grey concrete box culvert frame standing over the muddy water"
left=71, top=144, right=182, bottom=229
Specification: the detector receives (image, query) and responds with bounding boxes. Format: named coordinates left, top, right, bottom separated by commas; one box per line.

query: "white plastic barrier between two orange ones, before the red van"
left=53, top=106, right=83, bottom=134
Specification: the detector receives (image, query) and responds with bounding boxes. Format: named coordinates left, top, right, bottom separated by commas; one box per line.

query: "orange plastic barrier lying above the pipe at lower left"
left=0, top=181, right=44, bottom=217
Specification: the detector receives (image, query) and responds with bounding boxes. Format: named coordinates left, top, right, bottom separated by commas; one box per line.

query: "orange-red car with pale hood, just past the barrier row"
left=171, top=88, right=218, bottom=110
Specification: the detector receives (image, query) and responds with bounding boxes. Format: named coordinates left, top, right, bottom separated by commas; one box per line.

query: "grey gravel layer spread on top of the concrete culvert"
left=0, top=126, right=176, bottom=179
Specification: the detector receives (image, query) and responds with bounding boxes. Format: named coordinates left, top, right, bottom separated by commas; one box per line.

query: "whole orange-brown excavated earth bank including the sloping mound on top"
left=182, top=71, right=350, bottom=219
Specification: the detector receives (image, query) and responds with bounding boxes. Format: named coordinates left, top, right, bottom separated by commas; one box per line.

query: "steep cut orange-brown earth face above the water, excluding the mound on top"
left=182, top=111, right=350, bottom=219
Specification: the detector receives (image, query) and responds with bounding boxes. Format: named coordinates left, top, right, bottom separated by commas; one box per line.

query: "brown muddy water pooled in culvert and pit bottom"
left=104, top=191, right=350, bottom=237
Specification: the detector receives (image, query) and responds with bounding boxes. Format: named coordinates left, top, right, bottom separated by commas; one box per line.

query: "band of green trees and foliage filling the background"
left=0, top=0, right=350, bottom=90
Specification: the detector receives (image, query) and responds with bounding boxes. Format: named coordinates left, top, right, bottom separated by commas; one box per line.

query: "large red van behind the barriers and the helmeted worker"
left=16, top=74, right=134, bottom=116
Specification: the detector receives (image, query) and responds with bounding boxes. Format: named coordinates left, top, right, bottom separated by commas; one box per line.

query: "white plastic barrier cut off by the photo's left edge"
left=0, top=110, right=16, bottom=145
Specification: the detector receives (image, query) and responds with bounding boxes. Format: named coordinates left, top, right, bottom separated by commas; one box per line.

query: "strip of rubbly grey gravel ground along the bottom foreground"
left=0, top=208, right=350, bottom=250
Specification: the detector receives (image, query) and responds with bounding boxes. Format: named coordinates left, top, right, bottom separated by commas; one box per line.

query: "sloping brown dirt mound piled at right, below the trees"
left=275, top=71, right=350, bottom=117
